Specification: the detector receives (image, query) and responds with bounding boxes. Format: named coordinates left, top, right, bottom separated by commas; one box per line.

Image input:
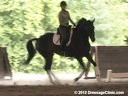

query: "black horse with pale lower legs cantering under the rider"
left=26, top=18, right=99, bottom=83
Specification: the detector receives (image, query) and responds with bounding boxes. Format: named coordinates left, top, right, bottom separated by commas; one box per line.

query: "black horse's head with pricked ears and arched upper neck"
left=76, top=18, right=95, bottom=42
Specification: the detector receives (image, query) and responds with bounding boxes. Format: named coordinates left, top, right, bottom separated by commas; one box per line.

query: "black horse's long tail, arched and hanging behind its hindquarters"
left=25, top=38, right=37, bottom=64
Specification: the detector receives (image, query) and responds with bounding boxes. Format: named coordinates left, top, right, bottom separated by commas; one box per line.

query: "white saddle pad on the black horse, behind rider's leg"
left=53, top=31, right=73, bottom=46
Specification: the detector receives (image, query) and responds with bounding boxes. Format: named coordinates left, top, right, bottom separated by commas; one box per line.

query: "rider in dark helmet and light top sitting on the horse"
left=58, top=1, right=76, bottom=51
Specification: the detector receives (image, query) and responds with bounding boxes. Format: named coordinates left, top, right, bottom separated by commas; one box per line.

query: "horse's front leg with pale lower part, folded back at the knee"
left=74, top=57, right=87, bottom=82
